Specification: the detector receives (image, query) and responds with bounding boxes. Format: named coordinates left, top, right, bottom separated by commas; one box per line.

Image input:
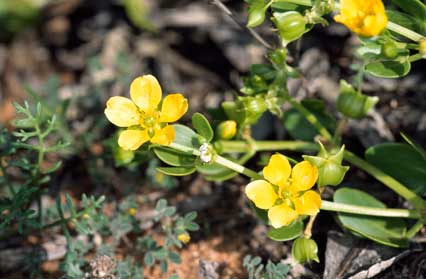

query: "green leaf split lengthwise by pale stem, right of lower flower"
left=334, top=188, right=408, bottom=247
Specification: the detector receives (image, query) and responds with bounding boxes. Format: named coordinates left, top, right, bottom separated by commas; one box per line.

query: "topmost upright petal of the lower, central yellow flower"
left=263, top=153, right=291, bottom=186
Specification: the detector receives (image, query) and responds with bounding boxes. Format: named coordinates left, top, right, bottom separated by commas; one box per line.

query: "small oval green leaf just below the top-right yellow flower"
left=365, top=61, right=411, bottom=78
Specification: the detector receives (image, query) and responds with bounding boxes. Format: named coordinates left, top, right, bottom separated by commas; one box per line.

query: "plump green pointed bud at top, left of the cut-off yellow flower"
left=272, top=11, right=306, bottom=45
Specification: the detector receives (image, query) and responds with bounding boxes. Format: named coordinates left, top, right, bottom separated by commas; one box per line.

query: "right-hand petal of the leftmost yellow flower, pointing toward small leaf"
left=160, top=94, right=188, bottom=122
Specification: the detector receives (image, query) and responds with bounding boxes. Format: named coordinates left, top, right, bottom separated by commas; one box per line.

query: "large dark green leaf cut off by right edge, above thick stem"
left=365, top=143, right=426, bottom=196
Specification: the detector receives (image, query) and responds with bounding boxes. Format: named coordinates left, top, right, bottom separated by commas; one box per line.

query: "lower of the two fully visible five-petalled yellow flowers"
left=245, top=154, right=321, bottom=228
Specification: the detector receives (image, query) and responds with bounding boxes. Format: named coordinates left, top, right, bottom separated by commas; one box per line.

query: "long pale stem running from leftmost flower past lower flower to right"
left=169, top=143, right=420, bottom=219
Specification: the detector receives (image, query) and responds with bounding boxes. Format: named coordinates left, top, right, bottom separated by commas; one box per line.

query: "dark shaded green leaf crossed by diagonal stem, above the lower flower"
left=284, top=100, right=336, bottom=141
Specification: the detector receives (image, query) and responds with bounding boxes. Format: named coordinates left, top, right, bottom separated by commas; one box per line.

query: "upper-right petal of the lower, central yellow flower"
left=291, top=161, right=318, bottom=192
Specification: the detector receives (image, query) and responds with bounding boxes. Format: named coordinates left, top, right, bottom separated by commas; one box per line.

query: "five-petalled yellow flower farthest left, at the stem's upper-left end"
left=105, top=75, right=188, bottom=150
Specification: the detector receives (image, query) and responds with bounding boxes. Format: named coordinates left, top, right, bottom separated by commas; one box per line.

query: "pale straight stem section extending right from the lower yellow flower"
left=321, top=200, right=420, bottom=219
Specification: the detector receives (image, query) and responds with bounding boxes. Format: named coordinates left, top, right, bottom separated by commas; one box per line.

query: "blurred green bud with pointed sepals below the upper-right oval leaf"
left=337, top=80, right=379, bottom=119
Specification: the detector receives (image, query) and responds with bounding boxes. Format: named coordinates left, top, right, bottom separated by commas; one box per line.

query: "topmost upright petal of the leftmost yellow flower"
left=130, top=75, right=162, bottom=114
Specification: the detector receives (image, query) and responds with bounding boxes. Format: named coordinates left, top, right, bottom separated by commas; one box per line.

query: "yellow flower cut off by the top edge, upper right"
left=334, top=0, right=388, bottom=37
